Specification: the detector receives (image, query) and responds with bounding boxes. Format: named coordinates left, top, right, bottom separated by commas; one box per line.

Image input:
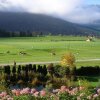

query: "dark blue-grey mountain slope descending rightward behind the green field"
left=0, top=12, right=98, bottom=35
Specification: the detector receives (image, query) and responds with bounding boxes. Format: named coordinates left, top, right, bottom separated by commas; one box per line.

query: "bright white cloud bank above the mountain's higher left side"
left=0, top=0, right=81, bottom=15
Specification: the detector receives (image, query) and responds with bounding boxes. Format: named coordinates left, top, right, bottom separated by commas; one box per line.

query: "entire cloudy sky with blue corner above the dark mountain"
left=0, top=0, right=100, bottom=24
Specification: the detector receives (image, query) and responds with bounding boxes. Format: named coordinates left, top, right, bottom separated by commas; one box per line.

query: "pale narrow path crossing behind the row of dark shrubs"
left=0, top=58, right=100, bottom=66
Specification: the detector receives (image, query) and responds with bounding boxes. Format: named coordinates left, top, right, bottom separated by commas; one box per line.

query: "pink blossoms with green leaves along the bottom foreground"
left=0, top=86, right=100, bottom=100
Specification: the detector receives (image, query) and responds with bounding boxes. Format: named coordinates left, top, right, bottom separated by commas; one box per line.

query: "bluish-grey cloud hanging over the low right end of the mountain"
left=66, top=5, right=100, bottom=24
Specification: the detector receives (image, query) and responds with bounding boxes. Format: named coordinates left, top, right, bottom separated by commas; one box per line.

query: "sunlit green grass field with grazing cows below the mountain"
left=0, top=36, right=100, bottom=66
